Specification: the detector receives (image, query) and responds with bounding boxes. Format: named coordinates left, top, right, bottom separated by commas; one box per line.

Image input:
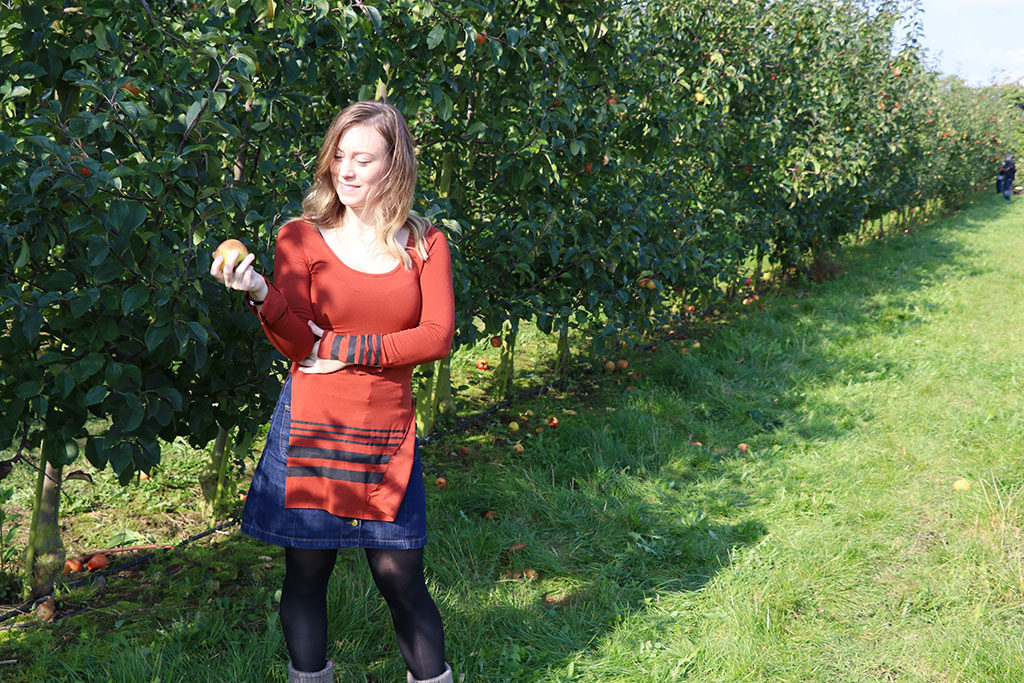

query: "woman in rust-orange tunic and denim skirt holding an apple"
left=210, top=101, right=455, bottom=683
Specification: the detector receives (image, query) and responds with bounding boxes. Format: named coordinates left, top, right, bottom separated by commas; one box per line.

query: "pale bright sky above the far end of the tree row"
left=921, top=0, right=1024, bottom=85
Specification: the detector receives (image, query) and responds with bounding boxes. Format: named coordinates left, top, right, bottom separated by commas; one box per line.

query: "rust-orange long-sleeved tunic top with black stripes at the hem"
left=249, top=220, right=455, bottom=521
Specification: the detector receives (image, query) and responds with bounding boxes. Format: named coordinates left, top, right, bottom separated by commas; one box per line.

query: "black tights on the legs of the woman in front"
left=281, top=548, right=445, bottom=679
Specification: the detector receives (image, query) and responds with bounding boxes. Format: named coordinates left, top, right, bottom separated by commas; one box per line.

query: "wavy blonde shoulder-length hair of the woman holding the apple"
left=302, top=99, right=429, bottom=269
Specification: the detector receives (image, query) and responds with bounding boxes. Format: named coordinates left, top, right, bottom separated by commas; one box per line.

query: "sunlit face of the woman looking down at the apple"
left=331, top=125, right=388, bottom=210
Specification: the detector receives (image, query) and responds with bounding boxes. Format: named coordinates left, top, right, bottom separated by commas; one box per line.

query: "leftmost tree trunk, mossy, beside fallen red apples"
left=23, top=445, right=65, bottom=600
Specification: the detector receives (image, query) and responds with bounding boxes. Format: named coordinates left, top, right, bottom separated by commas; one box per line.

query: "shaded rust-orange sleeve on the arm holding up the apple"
left=247, top=221, right=315, bottom=362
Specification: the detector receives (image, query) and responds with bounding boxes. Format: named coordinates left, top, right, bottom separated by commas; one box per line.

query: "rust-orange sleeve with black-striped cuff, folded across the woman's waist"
left=317, top=228, right=455, bottom=368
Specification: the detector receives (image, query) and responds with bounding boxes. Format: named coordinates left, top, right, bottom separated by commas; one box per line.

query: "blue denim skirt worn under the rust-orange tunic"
left=242, top=378, right=427, bottom=550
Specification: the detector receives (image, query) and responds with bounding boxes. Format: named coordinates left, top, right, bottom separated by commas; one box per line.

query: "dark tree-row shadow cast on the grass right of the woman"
left=415, top=191, right=1000, bottom=681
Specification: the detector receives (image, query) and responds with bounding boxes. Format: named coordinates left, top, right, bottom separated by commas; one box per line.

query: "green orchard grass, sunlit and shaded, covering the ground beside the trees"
left=0, top=189, right=1024, bottom=683
